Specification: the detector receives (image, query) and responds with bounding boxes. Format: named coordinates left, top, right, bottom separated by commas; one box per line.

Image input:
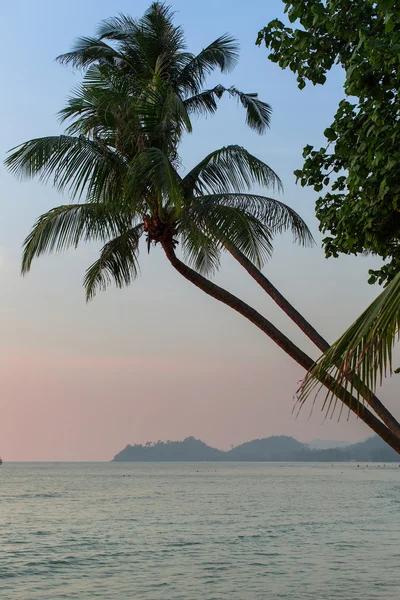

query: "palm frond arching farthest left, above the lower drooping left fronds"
left=5, top=135, right=126, bottom=200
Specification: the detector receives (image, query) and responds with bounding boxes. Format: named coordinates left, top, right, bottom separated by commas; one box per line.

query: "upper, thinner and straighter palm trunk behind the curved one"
left=224, top=240, right=400, bottom=437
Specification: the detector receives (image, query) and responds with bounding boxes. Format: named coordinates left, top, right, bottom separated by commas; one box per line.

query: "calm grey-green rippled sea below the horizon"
left=0, top=463, right=400, bottom=600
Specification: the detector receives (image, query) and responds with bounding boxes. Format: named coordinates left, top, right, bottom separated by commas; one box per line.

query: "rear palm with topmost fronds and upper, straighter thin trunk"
left=51, top=2, right=400, bottom=436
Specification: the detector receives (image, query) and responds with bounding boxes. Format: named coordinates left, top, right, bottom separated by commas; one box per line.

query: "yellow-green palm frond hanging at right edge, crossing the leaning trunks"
left=298, top=273, right=400, bottom=412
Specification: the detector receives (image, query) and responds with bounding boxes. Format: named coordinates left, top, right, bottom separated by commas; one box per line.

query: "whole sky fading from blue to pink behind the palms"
left=0, top=0, right=396, bottom=461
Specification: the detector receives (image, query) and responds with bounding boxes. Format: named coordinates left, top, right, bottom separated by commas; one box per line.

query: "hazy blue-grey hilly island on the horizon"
left=113, top=435, right=400, bottom=463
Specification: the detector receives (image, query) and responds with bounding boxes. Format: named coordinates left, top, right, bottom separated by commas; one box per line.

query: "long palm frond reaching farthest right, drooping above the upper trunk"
left=193, top=194, right=315, bottom=246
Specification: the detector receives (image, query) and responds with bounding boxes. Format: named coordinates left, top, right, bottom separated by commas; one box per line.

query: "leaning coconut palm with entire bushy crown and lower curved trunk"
left=6, top=3, right=400, bottom=450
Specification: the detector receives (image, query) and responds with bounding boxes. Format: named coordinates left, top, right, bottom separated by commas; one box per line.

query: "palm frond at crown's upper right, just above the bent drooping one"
left=176, top=34, right=239, bottom=94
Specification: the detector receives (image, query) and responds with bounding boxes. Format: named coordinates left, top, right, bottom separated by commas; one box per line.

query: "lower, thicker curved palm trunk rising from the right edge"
left=162, top=241, right=400, bottom=454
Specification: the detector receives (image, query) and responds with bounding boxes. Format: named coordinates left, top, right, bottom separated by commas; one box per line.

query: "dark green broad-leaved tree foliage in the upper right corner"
left=257, top=0, right=400, bottom=283
